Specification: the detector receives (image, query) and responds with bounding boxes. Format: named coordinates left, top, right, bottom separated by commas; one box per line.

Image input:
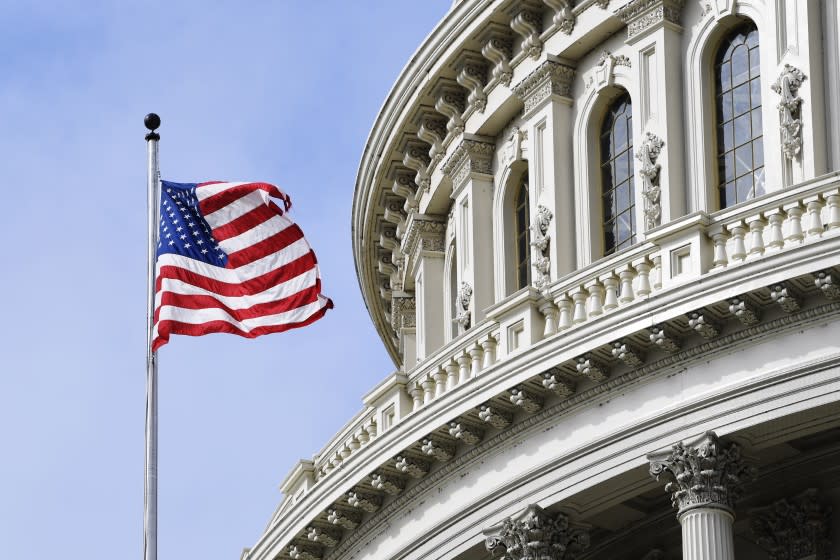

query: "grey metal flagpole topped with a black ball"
left=143, top=113, right=160, bottom=560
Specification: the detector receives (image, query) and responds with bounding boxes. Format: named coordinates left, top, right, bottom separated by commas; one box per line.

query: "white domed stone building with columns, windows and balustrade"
left=243, top=0, right=840, bottom=560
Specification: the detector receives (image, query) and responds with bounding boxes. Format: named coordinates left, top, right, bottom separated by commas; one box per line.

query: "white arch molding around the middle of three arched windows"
left=573, top=58, right=644, bottom=268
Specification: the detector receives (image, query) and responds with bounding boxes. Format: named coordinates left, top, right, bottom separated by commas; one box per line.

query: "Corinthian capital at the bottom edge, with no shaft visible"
left=484, top=505, right=589, bottom=560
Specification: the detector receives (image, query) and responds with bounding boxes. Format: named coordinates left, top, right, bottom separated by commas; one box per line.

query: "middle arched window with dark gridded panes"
left=601, top=93, right=636, bottom=255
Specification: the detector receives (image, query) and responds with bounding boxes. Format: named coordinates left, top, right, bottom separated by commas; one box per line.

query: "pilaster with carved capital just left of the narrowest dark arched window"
left=443, top=134, right=496, bottom=331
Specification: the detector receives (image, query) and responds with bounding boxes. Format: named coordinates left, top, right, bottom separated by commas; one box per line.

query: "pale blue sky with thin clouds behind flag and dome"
left=0, top=0, right=451, bottom=560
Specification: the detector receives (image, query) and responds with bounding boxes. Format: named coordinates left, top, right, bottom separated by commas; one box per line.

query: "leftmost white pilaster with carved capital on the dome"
left=400, top=213, right=446, bottom=360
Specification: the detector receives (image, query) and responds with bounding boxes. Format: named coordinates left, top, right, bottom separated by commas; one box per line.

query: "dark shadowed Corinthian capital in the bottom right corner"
left=750, top=488, right=831, bottom=560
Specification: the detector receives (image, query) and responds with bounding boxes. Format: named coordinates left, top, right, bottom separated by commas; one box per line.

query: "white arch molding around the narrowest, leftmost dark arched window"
left=493, top=160, right=534, bottom=301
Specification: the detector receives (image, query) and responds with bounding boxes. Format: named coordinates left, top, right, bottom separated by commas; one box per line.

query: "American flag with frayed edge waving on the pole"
left=152, top=181, right=332, bottom=350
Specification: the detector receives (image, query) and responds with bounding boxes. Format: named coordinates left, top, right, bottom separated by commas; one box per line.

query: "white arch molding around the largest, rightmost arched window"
left=683, top=0, right=783, bottom=212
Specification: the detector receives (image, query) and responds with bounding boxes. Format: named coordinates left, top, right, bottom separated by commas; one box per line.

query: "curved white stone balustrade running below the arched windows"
left=284, top=174, right=840, bottom=510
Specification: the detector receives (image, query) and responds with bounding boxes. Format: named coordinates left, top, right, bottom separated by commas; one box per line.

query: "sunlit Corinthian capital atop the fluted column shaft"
left=648, top=432, right=753, bottom=514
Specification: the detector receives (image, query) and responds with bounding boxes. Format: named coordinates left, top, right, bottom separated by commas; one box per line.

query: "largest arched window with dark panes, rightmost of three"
left=715, top=22, right=764, bottom=208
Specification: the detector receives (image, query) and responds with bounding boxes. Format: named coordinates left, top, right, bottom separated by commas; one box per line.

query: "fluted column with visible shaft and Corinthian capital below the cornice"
left=648, top=432, right=752, bottom=560
